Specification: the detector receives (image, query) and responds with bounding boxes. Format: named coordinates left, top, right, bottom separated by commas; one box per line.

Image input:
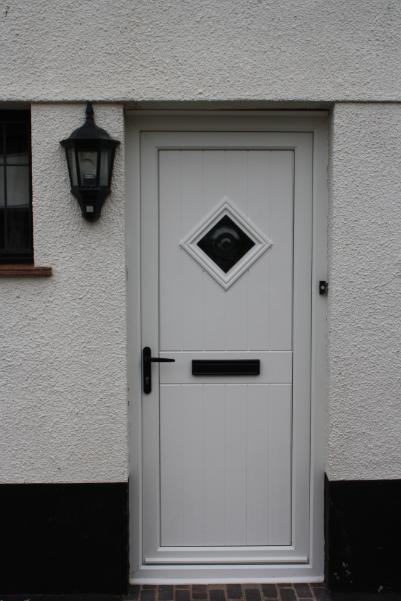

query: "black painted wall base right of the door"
left=325, top=478, right=401, bottom=593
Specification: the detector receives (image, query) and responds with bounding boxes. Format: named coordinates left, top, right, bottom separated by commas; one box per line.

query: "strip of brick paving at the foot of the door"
left=125, top=584, right=331, bottom=601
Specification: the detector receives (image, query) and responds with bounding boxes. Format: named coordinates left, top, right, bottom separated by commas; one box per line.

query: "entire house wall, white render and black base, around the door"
left=0, top=0, right=401, bottom=593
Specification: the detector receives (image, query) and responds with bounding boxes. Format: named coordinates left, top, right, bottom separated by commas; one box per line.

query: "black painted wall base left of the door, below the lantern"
left=0, top=482, right=128, bottom=594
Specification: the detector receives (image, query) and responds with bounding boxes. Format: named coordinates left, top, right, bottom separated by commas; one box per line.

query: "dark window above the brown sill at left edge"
left=0, top=111, right=33, bottom=264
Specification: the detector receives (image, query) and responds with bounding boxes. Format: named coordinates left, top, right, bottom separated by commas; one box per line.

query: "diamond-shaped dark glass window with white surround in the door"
left=180, top=196, right=273, bottom=290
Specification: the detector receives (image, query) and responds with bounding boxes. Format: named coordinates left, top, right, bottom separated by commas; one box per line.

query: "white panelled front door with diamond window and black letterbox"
left=141, top=132, right=312, bottom=566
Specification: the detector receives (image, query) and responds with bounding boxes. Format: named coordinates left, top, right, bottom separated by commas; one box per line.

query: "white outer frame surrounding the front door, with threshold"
left=126, top=111, right=328, bottom=583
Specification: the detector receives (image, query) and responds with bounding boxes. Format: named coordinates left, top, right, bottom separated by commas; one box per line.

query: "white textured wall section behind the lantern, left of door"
left=0, top=105, right=127, bottom=482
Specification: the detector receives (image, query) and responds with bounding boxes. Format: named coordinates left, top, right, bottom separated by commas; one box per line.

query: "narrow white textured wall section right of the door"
left=328, top=104, right=401, bottom=480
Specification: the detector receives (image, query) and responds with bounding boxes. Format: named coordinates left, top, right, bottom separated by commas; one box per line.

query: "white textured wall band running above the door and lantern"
left=0, top=0, right=401, bottom=101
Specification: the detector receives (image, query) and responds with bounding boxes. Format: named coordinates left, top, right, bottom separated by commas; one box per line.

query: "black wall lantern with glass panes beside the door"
left=60, top=102, right=120, bottom=221
